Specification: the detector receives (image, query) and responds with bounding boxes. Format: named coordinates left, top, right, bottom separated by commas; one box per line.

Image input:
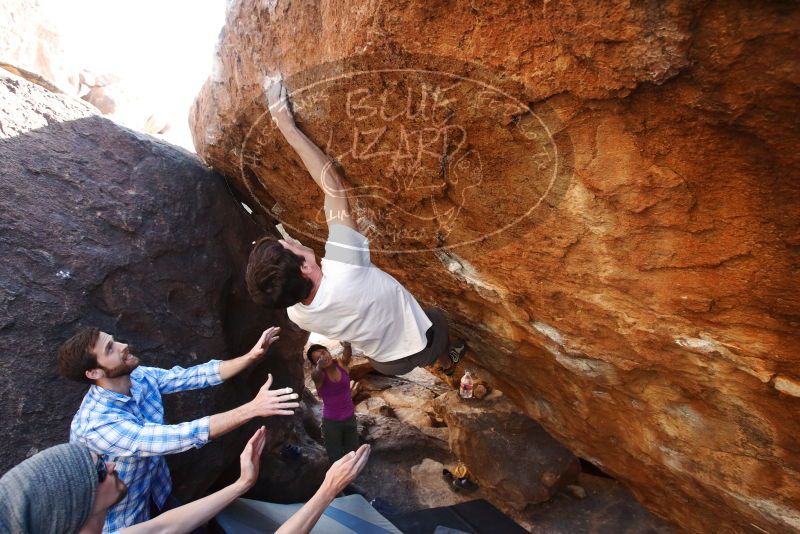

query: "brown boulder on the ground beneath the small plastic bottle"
left=434, top=391, right=580, bottom=510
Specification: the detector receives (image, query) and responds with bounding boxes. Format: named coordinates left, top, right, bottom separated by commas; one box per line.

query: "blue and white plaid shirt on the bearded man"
left=70, top=360, right=222, bottom=533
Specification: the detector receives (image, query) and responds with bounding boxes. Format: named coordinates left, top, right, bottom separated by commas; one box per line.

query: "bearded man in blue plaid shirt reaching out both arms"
left=59, top=328, right=299, bottom=533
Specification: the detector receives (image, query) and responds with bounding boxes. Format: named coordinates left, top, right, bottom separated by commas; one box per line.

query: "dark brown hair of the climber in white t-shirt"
left=245, top=237, right=314, bottom=308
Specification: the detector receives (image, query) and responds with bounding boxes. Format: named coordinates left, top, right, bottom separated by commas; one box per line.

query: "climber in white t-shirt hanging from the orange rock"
left=247, top=78, right=465, bottom=375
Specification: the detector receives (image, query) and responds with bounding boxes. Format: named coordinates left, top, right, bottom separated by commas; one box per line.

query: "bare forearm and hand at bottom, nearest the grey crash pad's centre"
left=275, top=445, right=370, bottom=534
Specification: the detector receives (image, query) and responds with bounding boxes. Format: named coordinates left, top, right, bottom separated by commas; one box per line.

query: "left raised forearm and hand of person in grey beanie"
left=120, top=426, right=267, bottom=534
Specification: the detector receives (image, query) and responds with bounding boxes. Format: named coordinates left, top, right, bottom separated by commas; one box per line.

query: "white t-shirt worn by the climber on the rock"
left=287, top=224, right=431, bottom=362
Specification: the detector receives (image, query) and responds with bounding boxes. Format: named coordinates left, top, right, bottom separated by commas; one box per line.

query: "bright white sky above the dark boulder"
left=41, top=0, right=226, bottom=150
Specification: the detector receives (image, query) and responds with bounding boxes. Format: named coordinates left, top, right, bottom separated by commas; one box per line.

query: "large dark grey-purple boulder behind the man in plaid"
left=0, top=75, right=324, bottom=506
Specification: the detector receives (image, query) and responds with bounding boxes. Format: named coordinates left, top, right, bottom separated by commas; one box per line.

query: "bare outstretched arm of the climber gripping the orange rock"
left=264, top=76, right=357, bottom=230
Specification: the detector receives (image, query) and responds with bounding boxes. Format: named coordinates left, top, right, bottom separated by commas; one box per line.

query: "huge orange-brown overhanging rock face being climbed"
left=191, top=0, right=800, bottom=532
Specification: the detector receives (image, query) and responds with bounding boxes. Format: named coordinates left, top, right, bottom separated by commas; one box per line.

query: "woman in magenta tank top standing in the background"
left=306, top=343, right=358, bottom=463
